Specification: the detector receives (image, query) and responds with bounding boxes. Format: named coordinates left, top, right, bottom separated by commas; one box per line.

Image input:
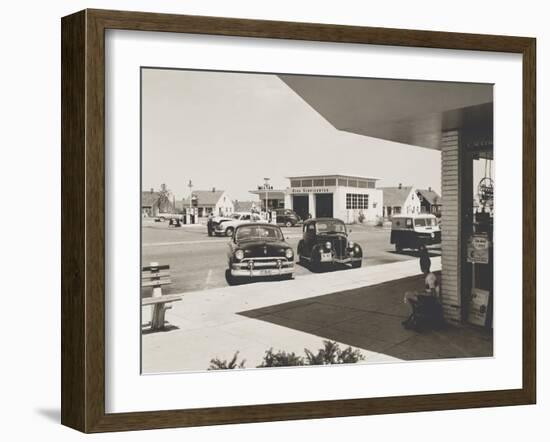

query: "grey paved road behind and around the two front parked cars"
left=142, top=221, right=440, bottom=296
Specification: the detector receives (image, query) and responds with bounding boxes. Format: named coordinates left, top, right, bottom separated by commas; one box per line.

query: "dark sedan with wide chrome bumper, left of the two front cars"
left=226, top=223, right=294, bottom=284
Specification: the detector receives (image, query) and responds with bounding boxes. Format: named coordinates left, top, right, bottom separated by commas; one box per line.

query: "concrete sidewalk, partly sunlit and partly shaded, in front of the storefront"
left=142, top=258, right=492, bottom=373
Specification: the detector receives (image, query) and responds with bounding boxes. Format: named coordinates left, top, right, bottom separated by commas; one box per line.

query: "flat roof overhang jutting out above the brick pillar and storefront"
left=279, top=75, right=493, bottom=149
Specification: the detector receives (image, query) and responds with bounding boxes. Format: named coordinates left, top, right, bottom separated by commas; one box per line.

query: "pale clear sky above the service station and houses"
left=142, top=69, right=470, bottom=200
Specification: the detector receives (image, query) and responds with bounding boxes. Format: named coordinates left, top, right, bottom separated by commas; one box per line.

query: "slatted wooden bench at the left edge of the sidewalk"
left=141, top=262, right=182, bottom=331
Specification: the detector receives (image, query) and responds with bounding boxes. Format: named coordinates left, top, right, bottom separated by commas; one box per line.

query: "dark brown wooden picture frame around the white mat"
left=61, top=10, right=536, bottom=432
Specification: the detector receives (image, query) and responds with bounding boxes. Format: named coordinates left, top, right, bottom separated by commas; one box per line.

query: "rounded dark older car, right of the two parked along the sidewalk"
left=298, top=218, right=363, bottom=271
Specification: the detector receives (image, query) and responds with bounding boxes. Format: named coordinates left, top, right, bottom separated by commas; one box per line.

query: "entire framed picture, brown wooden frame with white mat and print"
left=62, top=10, right=536, bottom=432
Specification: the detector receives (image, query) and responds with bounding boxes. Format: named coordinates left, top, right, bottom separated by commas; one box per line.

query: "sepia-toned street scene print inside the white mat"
left=141, top=67, right=495, bottom=374
